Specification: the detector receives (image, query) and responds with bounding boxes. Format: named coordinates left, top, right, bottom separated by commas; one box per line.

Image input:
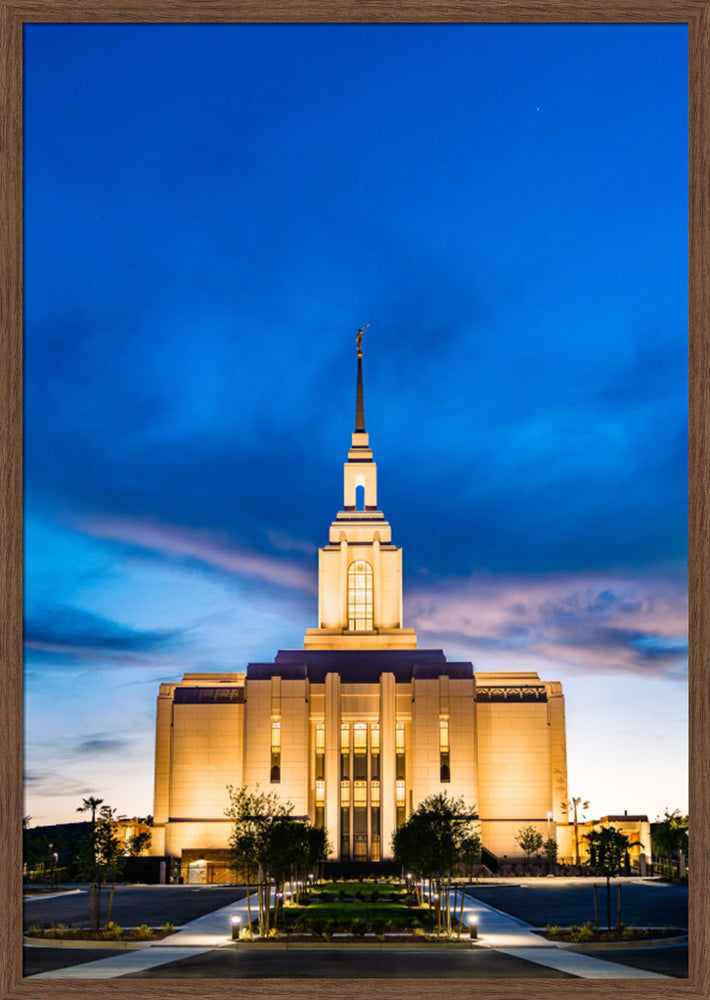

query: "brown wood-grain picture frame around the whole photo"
left=0, top=0, right=710, bottom=1000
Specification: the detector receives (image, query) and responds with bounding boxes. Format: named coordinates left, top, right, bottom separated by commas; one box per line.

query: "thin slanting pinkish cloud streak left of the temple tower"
left=81, top=517, right=316, bottom=593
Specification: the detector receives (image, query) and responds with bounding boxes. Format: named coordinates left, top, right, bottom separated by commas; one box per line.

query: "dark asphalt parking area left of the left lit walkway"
left=23, top=885, right=244, bottom=927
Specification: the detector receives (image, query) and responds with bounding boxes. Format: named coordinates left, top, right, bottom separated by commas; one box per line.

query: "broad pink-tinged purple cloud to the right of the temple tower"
left=408, top=574, right=688, bottom=680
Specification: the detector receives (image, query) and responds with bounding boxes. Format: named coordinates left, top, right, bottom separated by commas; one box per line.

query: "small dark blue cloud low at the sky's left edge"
left=24, top=606, right=184, bottom=662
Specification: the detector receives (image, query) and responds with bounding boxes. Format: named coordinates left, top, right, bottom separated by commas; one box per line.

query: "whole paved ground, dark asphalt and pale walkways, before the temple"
left=24, top=880, right=687, bottom=979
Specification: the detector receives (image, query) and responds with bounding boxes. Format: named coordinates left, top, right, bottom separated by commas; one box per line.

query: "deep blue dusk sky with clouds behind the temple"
left=24, top=25, right=687, bottom=825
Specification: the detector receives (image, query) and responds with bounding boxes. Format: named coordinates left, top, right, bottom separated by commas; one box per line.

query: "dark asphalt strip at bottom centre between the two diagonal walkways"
left=122, top=948, right=575, bottom=979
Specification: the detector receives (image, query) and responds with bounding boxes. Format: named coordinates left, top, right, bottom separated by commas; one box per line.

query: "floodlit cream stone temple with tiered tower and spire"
left=151, top=334, right=572, bottom=866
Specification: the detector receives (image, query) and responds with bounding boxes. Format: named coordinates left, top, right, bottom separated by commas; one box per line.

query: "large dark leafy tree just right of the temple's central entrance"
left=392, top=794, right=480, bottom=931
